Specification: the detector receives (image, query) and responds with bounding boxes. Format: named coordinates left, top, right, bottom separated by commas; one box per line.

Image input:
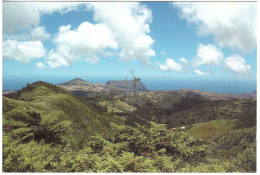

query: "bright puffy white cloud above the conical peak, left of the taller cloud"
left=54, top=22, right=118, bottom=55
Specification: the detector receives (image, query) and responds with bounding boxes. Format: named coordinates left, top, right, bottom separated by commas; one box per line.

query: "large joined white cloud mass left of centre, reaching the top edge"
left=38, top=2, right=155, bottom=68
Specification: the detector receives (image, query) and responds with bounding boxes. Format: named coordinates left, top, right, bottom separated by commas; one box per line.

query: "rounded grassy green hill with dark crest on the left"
left=3, top=82, right=123, bottom=146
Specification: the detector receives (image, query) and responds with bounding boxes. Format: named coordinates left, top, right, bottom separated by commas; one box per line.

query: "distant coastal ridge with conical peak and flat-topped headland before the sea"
left=3, top=78, right=257, bottom=100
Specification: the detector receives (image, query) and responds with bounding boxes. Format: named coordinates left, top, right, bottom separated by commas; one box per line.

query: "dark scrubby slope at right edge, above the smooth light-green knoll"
left=167, top=99, right=256, bottom=127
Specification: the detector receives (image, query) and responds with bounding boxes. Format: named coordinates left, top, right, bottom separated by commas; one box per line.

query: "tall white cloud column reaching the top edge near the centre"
left=89, top=2, right=155, bottom=66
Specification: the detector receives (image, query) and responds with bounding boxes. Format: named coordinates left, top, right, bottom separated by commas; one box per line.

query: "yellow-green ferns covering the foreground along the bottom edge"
left=3, top=119, right=256, bottom=172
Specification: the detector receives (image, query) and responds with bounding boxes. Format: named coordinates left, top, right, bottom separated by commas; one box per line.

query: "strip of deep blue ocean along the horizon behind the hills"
left=3, top=77, right=256, bottom=94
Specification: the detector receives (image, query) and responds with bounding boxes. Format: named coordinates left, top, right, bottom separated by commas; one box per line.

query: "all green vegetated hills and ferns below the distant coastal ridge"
left=3, top=82, right=256, bottom=172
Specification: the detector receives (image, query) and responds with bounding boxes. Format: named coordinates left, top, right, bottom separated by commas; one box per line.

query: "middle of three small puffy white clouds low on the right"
left=193, top=44, right=223, bottom=66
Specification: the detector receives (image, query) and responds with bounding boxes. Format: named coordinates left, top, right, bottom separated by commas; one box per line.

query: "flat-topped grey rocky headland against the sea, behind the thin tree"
left=106, top=80, right=147, bottom=91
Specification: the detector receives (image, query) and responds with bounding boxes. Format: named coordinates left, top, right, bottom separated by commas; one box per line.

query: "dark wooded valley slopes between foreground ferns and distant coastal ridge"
left=67, top=89, right=256, bottom=127
